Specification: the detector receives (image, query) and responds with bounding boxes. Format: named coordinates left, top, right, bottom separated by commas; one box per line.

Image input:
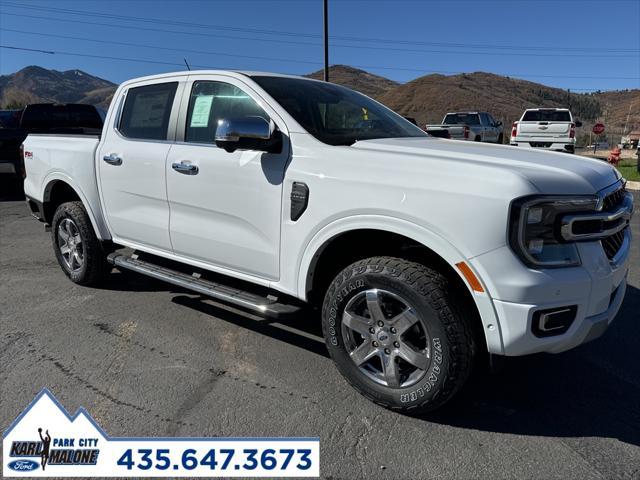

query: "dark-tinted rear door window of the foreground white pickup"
left=118, top=82, right=178, bottom=140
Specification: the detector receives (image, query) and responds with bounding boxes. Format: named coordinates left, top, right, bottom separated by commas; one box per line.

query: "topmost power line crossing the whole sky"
left=2, top=2, right=640, bottom=56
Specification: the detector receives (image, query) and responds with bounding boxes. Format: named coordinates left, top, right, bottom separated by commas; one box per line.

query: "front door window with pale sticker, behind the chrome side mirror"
left=184, top=81, right=269, bottom=143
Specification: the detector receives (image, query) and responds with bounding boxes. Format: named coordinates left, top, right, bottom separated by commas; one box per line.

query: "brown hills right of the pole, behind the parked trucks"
left=309, top=65, right=640, bottom=141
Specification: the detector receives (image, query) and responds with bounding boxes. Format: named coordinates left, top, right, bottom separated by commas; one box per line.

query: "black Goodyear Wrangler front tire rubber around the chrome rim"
left=322, top=257, right=476, bottom=414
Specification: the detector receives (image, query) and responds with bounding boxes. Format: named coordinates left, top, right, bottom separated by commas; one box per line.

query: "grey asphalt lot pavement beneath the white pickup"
left=0, top=182, right=640, bottom=480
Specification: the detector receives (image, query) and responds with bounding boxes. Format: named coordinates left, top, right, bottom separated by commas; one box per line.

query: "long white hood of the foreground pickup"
left=351, top=137, right=620, bottom=195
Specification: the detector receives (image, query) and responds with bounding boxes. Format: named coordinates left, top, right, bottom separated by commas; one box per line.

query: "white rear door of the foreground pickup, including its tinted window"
left=98, top=77, right=185, bottom=251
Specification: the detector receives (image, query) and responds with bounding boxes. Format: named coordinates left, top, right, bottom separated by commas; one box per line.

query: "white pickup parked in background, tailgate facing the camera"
left=510, top=108, right=582, bottom=153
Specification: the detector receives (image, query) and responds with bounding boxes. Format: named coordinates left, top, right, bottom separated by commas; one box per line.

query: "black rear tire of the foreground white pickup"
left=51, top=201, right=111, bottom=286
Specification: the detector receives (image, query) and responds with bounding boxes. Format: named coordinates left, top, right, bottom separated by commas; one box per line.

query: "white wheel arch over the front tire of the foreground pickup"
left=298, top=216, right=503, bottom=354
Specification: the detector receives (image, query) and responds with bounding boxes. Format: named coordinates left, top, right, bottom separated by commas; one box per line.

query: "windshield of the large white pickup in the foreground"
left=252, top=76, right=427, bottom=145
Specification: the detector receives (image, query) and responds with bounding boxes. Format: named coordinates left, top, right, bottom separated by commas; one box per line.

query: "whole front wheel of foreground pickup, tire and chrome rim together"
left=322, top=257, right=475, bottom=414
